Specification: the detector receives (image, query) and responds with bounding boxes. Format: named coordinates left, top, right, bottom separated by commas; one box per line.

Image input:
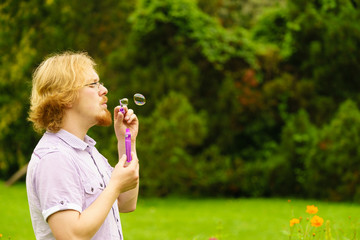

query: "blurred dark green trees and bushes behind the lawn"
left=0, top=0, right=360, bottom=201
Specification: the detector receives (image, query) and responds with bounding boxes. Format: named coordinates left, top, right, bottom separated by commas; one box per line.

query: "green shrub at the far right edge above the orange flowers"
left=303, top=100, right=360, bottom=201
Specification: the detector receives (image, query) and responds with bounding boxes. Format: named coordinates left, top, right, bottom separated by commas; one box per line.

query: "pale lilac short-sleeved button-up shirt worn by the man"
left=26, top=130, right=123, bottom=240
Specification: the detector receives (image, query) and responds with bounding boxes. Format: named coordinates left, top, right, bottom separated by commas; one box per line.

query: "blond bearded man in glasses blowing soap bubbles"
left=26, top=52, right=139, bottom=240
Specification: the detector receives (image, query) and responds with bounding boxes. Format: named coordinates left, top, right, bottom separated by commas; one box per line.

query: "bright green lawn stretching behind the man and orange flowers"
left=0, top=182, right=360, bottom=240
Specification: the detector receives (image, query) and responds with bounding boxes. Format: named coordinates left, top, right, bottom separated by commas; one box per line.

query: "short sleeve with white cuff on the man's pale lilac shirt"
left=34, top=151, right=83, bottom=221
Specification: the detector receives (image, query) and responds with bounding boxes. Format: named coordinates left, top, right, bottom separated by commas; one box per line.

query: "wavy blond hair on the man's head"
left=28, top=51, right=95, bottom=133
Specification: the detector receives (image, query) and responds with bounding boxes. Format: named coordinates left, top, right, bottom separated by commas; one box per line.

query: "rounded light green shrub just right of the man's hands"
left=137, top=92, right=207, bottom=196
